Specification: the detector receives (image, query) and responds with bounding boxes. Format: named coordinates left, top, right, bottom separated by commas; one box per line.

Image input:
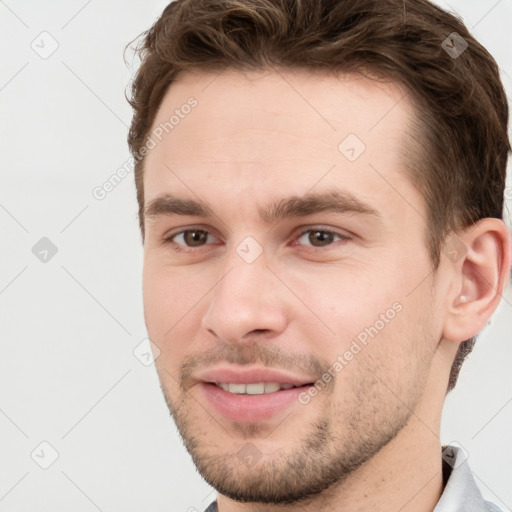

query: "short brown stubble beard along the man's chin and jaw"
left=162, top=368, right=421, bottom=505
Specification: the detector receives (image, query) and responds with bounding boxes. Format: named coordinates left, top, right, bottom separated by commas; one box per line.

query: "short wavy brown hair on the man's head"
left=128, top=0, right=510, bottom=392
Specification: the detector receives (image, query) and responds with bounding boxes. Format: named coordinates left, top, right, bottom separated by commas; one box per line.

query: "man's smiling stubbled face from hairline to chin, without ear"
left=143, top=71, right=443, bottom=503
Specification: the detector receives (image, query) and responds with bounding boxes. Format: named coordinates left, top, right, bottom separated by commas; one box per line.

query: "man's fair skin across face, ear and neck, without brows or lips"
left=143, top=70, right=510, bottom=512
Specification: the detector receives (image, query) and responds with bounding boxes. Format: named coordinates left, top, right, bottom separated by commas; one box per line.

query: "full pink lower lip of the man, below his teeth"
left=200, top=382, right=311, bottom=423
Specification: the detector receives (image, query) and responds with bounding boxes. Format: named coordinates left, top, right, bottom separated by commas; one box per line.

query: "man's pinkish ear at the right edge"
left=443, top=218, right=511, bottom=342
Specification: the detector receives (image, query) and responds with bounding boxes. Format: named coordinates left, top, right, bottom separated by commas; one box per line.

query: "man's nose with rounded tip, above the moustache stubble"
left=201, top=248, right=289, bottom=343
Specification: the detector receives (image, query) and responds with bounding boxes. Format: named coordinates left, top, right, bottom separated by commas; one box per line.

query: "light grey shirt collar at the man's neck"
left=204, top=445, right=503, bottom=512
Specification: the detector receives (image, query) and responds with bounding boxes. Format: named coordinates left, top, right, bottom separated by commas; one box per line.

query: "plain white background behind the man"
left=0, top=0, right=512, bottom=512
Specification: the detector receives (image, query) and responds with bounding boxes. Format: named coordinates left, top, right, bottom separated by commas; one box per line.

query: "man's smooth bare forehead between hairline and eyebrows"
left=144, top=66, right=421, bottom=222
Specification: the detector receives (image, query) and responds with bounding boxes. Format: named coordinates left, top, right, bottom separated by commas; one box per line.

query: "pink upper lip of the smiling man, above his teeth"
left=197, top=367, right=316, bottom=386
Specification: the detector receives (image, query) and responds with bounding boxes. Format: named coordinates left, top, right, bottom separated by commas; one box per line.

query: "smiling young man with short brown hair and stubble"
left=129, top=0, right=511, bottom=512
